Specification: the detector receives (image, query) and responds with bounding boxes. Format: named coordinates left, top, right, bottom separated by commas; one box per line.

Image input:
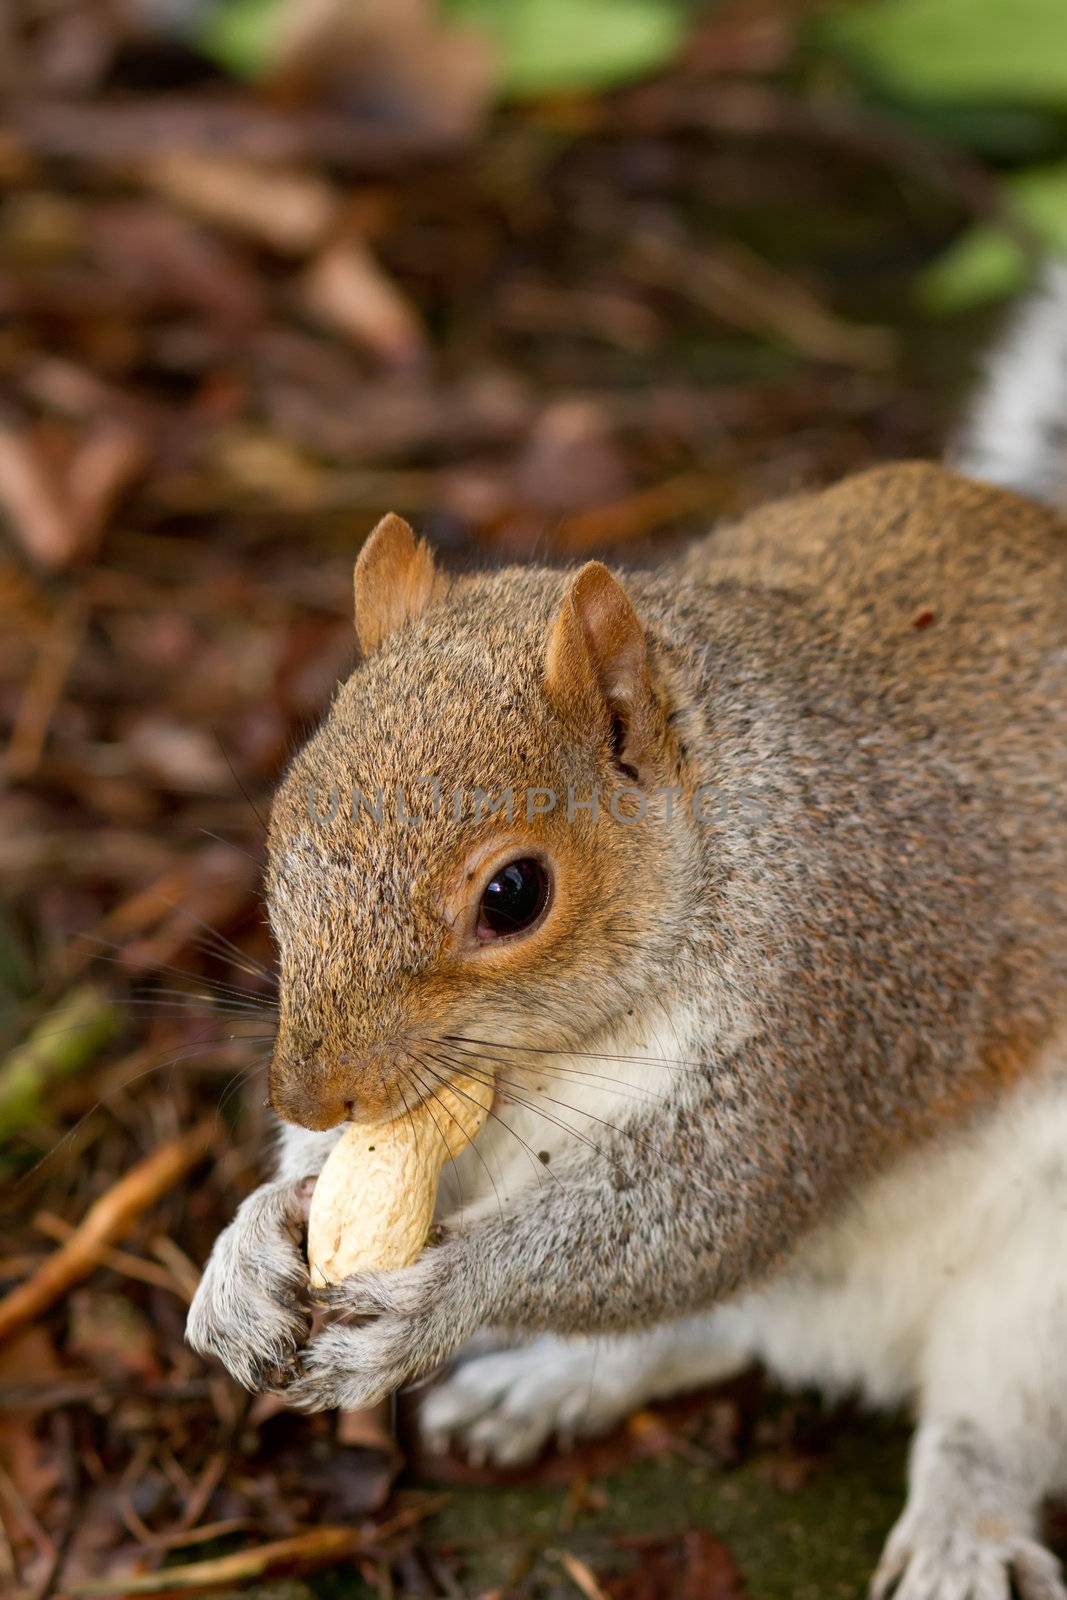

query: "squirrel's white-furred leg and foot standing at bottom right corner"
left=872, top=1203, right=1067, bottom=1600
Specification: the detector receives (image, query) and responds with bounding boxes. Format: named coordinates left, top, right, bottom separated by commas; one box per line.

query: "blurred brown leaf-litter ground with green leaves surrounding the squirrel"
left=0, top=0, right=1067, bottom=1600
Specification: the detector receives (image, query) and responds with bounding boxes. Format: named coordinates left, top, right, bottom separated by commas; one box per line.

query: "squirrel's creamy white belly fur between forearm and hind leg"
left=712, top=1051, right=1067, bottom=1403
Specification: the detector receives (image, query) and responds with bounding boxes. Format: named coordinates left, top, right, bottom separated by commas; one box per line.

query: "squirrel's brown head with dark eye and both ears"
left=267, top=517, right=691, bottom=1128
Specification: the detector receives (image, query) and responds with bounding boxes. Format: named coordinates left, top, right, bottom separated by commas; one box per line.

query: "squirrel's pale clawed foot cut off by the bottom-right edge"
left=870, top=1512, right=1067, bottom=1600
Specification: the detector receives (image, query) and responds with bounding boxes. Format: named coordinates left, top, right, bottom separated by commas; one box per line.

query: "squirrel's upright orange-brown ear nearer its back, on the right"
left=544, top=562, right=654, bottom=778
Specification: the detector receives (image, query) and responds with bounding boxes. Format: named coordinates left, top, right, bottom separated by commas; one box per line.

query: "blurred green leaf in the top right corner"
left=821, top=0, right=1067, bottom=109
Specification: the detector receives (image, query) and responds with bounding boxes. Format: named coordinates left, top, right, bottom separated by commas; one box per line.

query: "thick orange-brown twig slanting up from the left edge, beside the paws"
left=0, top=1120, right=216, bottom=1339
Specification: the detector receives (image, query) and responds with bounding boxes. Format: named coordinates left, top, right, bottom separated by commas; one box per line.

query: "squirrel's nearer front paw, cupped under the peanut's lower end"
left=278, top=1240, right=485, bottom=1411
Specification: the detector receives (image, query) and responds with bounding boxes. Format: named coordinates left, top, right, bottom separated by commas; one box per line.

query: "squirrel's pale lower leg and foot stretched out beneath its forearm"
left=419, top=1312, right=747, bottom=1467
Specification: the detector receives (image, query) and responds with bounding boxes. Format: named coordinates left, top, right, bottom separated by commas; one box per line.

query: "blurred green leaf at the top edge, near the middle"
left=445, top=0, right=686, bottom=96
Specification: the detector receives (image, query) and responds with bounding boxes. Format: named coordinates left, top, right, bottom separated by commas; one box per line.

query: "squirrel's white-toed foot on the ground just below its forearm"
left=418, top=1336, right=659, bottom=1467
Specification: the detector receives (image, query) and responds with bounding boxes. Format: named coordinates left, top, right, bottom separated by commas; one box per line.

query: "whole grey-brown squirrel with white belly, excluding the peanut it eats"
left=189, top=267, right=1067, bottom=1600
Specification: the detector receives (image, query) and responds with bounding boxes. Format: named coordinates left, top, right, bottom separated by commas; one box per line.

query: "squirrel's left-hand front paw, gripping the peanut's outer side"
left=186, top=1179, right=312, bottom=1390
